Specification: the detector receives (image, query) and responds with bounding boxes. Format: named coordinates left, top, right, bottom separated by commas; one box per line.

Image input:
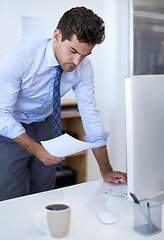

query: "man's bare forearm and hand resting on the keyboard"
left=93, top=146, right=127, bottom=183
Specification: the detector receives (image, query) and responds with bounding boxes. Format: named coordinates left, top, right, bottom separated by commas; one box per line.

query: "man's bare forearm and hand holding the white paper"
left=13, top=133, right=64, bottom=166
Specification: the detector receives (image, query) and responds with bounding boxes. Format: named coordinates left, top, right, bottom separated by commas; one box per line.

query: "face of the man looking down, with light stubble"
left=53, top=29, right=94, bottom=72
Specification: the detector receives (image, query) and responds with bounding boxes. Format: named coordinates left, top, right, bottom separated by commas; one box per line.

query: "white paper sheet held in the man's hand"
left=41, top=133, right=105, bottom=157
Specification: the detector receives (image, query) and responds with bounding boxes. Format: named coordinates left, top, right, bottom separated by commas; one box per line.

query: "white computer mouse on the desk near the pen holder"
left=97, top=210, right=117, bottom=224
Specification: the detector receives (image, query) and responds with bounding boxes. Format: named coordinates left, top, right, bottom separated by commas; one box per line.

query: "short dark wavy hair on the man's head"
left=57, top=7, right=105, bottom=45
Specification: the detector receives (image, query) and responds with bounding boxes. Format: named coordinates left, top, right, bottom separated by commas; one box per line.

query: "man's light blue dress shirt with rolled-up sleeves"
left=0, top=39, right=109, bottom=146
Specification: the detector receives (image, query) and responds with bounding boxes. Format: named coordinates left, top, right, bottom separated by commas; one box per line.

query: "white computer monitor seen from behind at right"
left=125, top=75, right=164, bottom=201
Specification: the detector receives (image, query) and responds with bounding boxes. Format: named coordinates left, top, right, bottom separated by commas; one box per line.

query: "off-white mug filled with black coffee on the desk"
left=36, top=203, right=71, bottom=238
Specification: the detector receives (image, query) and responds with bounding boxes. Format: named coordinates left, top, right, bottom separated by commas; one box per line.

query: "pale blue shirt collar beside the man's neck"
left=46, top=39, right=59, bottom=67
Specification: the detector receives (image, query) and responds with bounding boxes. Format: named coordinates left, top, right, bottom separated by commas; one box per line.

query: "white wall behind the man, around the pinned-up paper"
left=0, top=0, right=130, bottom=180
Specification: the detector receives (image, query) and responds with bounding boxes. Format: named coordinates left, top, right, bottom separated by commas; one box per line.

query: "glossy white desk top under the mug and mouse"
left=0, top=179, right=164, bottom=240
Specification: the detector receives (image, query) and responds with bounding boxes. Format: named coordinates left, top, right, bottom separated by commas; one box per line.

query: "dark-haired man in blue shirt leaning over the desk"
left=0, top=7, right=126, bottom=200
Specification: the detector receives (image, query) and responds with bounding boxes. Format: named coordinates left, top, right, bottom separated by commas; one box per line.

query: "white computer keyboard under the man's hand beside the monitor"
left=103, top=183, right=127, bottom=197
